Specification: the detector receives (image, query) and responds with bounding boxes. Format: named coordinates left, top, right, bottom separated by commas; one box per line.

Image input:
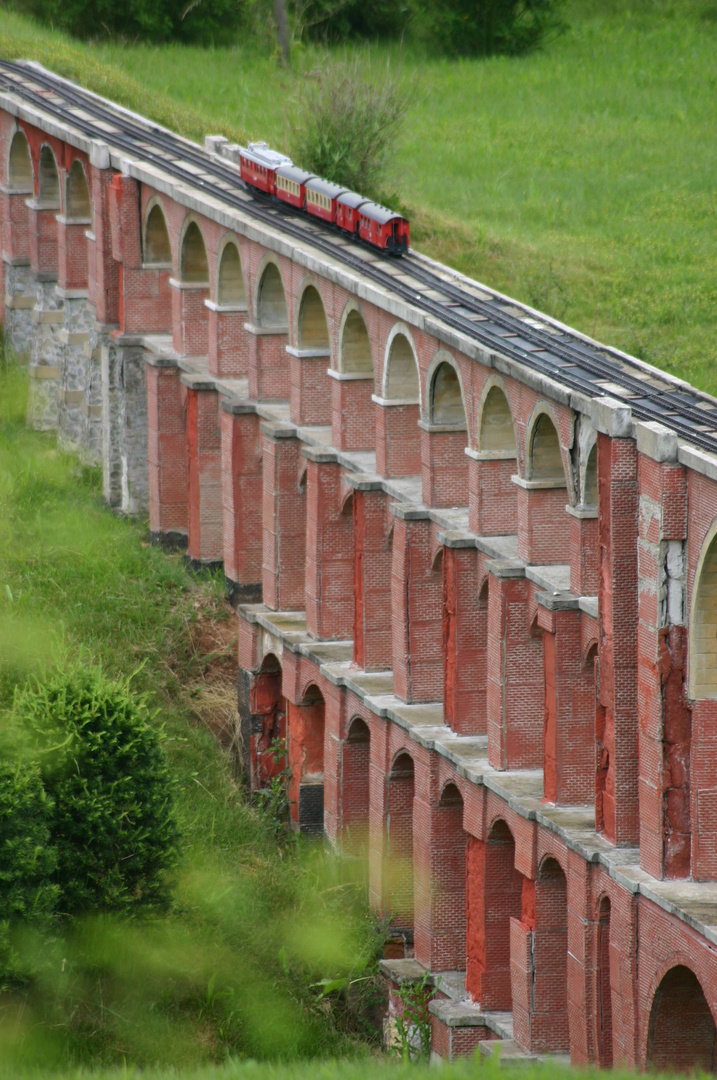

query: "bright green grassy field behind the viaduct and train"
left=0, top=0, right=717, bottom=391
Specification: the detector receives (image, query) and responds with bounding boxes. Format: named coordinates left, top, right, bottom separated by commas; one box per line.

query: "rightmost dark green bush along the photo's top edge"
left=411, top=0, right=566, bottom=56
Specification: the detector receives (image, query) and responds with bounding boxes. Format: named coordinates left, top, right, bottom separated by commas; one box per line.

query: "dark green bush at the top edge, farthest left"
left=19, top=0, right=243, bottom=42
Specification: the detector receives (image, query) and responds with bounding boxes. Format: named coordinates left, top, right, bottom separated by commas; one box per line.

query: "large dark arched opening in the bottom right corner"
left=647, top=964, right=717, bottom=1072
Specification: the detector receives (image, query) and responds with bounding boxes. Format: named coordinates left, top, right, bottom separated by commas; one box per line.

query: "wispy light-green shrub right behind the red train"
left=292, top=56, right=412, bottom=198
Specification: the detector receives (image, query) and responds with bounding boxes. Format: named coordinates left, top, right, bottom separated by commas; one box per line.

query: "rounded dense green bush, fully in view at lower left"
left=13, top=666, right=177, bottom=915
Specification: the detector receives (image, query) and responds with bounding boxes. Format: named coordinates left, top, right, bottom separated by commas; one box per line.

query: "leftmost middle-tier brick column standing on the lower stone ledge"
left=261, top=423, right=307, bottom=611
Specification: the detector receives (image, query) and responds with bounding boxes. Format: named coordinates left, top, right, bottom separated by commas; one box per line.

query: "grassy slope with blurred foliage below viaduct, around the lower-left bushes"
left=0, top=356, right=381, bottom=1075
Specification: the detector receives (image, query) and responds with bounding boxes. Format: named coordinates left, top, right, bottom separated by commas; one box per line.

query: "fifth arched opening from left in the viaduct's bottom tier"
left=427, top=783, right=465, bottom=971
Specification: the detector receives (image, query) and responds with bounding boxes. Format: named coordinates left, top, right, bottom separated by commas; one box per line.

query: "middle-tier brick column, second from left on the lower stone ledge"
left=301, top=446, right=354, bottom=639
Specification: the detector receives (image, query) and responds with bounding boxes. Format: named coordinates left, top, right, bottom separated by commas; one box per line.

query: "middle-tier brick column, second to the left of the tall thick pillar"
left=486, top=559, right=544, bottom=769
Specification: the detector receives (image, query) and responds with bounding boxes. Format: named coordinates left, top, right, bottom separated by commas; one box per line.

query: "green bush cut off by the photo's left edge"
left=0, top=760, right=59, bottom=988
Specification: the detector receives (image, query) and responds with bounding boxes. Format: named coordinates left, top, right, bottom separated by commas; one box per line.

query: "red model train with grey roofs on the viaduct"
left=239, top=143, right=409, bottom=255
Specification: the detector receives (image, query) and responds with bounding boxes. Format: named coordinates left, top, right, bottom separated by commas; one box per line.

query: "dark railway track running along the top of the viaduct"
left=0, top=60, right=717, bottom=453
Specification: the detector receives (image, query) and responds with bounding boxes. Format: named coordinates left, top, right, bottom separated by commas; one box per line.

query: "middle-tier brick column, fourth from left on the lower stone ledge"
left=391, top=503, right=443, bottom=704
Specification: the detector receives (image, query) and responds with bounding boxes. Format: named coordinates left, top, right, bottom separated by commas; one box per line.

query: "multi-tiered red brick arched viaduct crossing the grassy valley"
left=0, top=67, right=717, bottom=1069
